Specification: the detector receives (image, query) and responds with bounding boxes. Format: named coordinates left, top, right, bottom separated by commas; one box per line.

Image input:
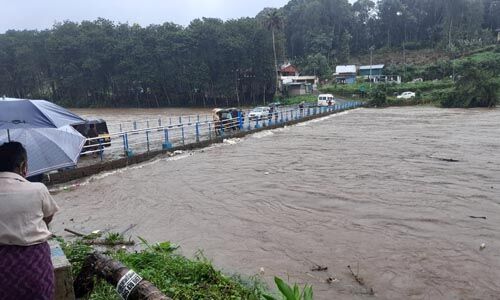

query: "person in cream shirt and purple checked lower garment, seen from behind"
left=0, top=142, right=59, bottom=300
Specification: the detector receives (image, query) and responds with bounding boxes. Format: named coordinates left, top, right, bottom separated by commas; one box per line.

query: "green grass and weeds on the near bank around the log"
left=61, top=241, right=272, bottom=300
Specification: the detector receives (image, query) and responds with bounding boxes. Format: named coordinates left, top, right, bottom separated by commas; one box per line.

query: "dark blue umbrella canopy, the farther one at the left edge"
left=0, top=98, right=85, bottom=130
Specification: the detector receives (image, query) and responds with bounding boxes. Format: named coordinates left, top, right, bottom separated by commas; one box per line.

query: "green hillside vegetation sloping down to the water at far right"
left=321, top=46, right=500, bottom=107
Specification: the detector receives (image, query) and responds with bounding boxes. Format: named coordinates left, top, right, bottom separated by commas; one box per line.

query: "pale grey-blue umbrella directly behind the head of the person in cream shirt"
left=0, top=125, right=85, bottom=176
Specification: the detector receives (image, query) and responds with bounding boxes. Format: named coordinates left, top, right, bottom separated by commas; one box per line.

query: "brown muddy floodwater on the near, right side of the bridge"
left=54, top=108, right=500, bottom=299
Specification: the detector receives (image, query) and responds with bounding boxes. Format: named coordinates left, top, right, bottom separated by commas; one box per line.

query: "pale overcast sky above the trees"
left=0, top=0, right=288, bottom=33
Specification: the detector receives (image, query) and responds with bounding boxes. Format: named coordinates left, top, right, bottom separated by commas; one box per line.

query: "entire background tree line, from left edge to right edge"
left=0, top=0, right=500, bottom=107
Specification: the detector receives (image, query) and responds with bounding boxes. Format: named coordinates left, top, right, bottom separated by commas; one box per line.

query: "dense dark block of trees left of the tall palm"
left=0, top=18, right=274, bottom=107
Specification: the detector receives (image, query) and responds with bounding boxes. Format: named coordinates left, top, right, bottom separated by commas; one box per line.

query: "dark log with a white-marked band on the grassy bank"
left=74, top=252, right=171, bottom=300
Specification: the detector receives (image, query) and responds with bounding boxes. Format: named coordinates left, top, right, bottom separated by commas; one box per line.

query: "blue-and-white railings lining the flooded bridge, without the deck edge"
left=81, top=101, right=362, bottom=160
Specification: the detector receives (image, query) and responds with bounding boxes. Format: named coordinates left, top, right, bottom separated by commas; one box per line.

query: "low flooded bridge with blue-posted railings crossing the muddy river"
left=45, top=101, right=363, bottom=185
